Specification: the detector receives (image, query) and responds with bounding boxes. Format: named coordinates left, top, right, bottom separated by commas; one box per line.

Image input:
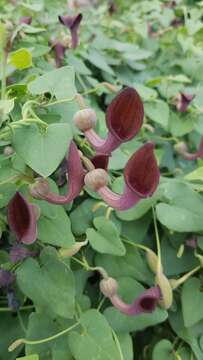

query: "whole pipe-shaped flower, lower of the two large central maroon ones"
left=85, top=142, right=160, bottom=210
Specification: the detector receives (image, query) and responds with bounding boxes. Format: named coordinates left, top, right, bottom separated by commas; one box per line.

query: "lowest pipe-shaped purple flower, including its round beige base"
left=100, top=278, right=161, bottom=316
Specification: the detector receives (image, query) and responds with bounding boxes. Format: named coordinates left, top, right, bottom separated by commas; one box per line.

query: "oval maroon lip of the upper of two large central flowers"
left=106, top=87, right=144, bottom=141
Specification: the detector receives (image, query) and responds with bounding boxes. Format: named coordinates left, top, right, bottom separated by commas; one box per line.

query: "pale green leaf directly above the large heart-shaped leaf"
left=28, top=66, right=76, bottom=99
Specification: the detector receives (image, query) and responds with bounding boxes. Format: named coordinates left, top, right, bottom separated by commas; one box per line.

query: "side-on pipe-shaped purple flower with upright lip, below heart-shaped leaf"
left=30, top=141, right=85, bottom=204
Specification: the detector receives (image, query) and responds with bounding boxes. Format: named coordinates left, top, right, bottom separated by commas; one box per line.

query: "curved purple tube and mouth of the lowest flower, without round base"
left=110, top=286, right=161, bottom=316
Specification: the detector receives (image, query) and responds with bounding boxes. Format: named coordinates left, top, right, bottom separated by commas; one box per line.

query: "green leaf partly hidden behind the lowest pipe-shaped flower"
left=104, top=277, right=167, bottom=333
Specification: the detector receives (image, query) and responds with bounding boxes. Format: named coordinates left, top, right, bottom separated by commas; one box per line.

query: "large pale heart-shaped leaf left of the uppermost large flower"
left=12, top=124, right=72, bottom=177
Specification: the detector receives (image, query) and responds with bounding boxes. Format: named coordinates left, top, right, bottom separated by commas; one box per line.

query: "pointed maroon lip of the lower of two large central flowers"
left=124, top=142, right=160, bottom=198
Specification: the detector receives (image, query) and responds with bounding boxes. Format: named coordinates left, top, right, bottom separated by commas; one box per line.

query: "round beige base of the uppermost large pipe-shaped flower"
left=73, top=109, right=96, bottom=131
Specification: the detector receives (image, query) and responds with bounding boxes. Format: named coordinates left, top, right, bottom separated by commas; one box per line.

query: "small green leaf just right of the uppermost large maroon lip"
left=145, top=100, right=169, bottom=129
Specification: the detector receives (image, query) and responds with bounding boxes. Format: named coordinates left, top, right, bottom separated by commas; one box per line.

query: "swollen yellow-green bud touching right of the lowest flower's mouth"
left=155, top=272, right=173, bottom=309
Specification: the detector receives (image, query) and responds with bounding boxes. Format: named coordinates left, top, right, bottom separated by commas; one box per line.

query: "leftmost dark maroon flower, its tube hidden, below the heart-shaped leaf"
left=8, top=192, right=37, bottom=244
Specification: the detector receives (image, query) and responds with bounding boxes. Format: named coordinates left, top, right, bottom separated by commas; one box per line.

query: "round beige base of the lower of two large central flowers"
left=84, top=169, right=108, bottom=191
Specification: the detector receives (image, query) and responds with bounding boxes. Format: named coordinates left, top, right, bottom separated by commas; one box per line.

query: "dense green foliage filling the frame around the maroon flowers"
left=0, top=0, right=203, bottom=360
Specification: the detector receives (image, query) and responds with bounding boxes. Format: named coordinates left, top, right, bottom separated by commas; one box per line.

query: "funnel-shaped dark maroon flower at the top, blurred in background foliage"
left=58, top=14, right=82, bottom=49
